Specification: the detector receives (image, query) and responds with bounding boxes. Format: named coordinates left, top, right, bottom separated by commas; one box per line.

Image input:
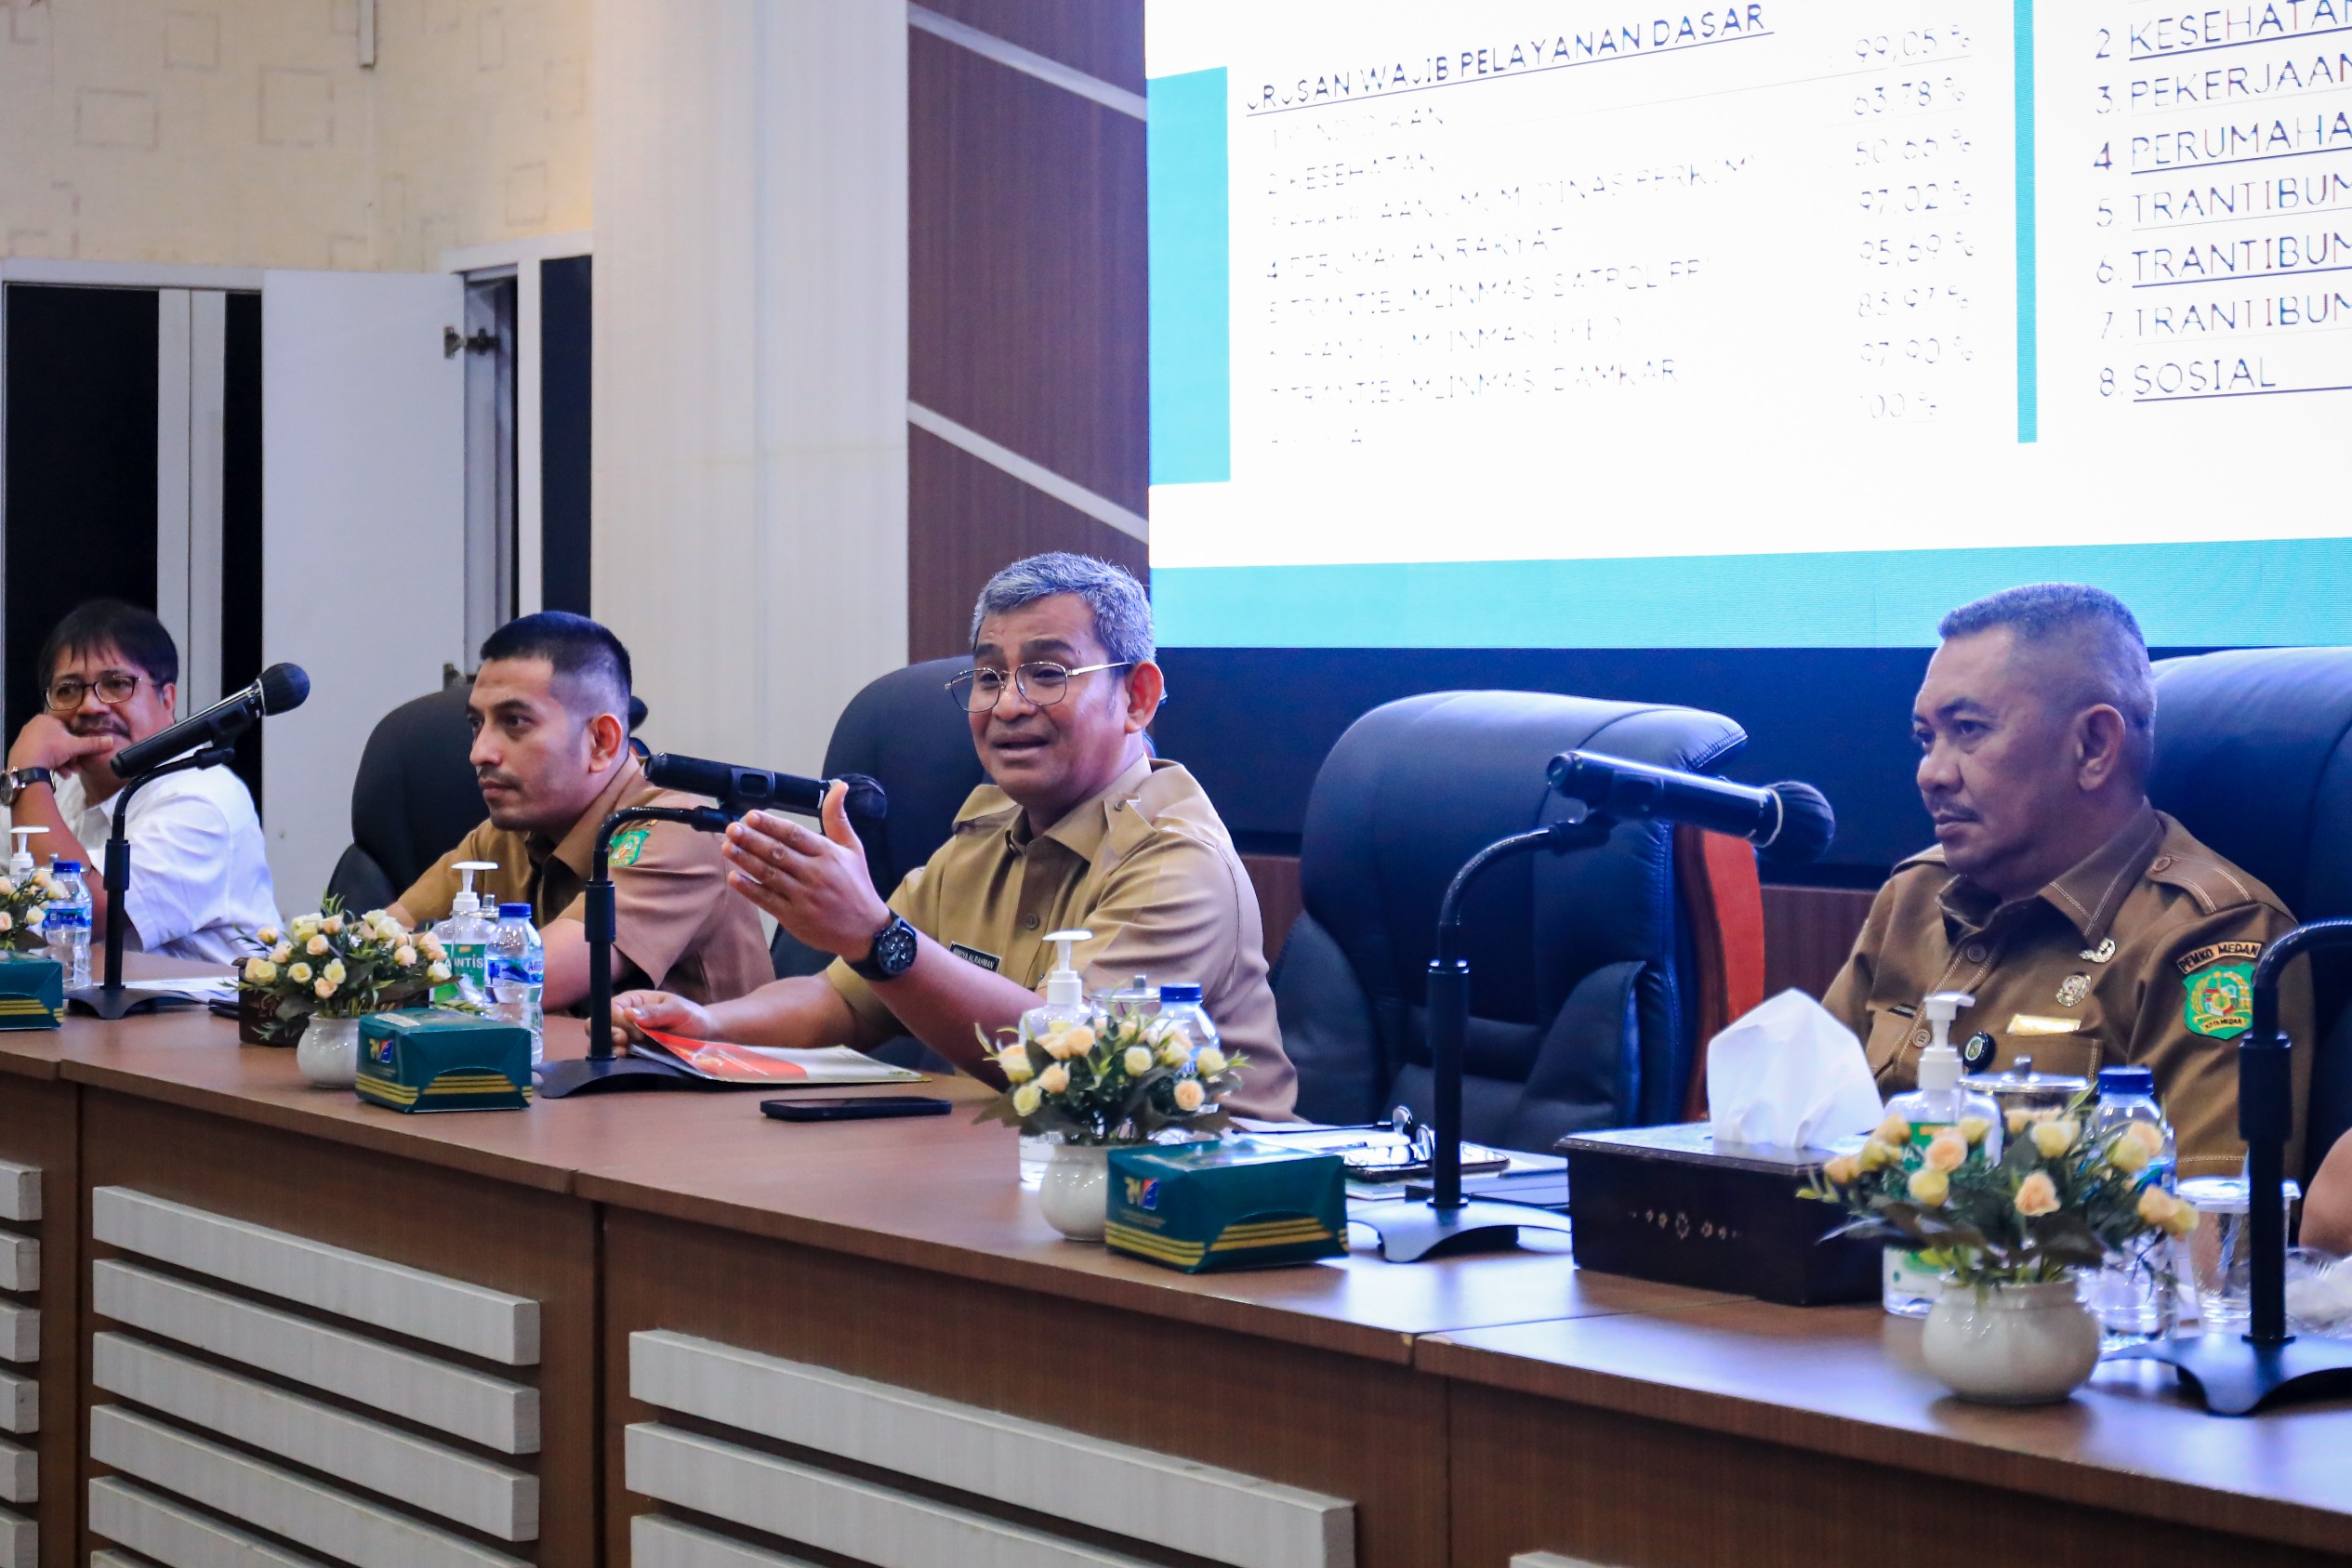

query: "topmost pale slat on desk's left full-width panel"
left=89, top=1187, right=538, bottom=1365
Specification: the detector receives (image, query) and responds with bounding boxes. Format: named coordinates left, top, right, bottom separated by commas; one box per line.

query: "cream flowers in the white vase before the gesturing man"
left=978, top=1013, right=1247, bottom=1147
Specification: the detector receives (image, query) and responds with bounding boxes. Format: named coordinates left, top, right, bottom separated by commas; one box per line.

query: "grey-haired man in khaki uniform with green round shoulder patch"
left=1823, top=583, right=2312, bottom=1176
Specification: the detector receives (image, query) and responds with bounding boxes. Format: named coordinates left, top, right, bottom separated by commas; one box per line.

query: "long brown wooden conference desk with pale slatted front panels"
left=0, top=973, right=2352, bottom=1568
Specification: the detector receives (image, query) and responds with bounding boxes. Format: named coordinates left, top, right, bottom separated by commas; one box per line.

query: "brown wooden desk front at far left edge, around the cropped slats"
left=0, top=1081, right=83, bottom=1568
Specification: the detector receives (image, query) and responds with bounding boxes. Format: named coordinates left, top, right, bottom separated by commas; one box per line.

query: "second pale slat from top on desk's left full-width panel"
left=89, top=1258, right=538, bottom=1453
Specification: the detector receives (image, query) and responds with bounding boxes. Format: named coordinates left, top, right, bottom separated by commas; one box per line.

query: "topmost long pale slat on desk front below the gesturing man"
left=628, top=1333, right=1354, bottom=1568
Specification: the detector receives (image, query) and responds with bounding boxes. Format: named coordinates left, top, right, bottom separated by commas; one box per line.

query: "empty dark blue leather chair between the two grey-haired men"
left=1275, top=692, right=1748, bottom=1150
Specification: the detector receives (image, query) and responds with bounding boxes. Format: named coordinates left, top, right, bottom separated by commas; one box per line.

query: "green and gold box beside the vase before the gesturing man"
left=1103, top=1138, right=1348, bottom=1274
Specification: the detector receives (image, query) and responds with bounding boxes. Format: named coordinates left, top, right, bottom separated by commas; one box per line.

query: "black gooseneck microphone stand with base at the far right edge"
left=2109, top=919, right=2352, bottom=1416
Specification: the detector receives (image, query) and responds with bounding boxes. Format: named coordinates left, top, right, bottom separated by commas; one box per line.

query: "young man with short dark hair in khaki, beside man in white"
left=393, top=612, right=776, bottom=1008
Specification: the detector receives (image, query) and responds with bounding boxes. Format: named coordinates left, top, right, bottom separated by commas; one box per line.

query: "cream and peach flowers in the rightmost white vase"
left=1802, top=1093, right=2197, bottom=1285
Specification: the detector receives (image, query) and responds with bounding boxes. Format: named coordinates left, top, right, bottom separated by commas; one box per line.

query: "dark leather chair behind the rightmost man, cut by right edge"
left=2147, top=649, right=2352, bottom=1168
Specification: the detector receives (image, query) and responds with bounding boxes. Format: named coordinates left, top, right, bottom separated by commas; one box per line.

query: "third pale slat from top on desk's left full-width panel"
left=89, top=1333, right=538, bottom=1540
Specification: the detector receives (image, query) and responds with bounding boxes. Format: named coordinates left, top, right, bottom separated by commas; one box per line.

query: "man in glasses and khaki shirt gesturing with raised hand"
left=616, top=555, right=1296, bottom=1116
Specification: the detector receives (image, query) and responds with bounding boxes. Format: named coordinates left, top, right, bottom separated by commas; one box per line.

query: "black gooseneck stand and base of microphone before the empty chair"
left=1348, top=816, right=1609, bottom=1262
